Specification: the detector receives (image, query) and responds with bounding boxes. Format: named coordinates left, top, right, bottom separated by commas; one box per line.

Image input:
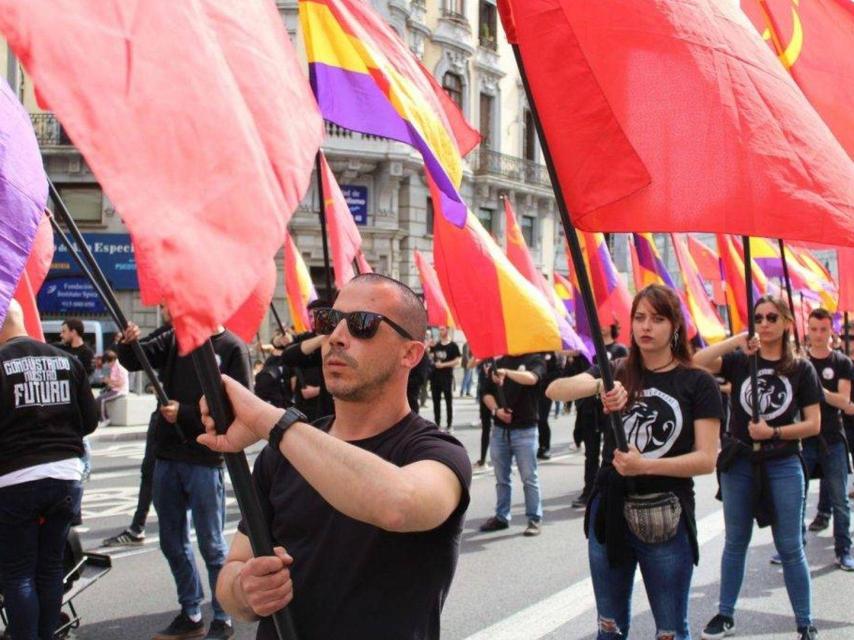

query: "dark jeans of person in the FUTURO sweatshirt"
left=0, top=478, right=83, bottom=640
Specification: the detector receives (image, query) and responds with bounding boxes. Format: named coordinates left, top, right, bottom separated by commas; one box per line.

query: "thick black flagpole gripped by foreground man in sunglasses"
left=192, top=339, right=297, bottom=640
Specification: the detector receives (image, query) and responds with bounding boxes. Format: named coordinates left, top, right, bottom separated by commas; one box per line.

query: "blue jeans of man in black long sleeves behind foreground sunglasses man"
left=154, top=459, right=229, bottom=620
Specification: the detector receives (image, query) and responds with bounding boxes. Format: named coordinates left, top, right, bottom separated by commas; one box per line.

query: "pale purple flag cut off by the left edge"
left=0, top=81, right=47, bottom=324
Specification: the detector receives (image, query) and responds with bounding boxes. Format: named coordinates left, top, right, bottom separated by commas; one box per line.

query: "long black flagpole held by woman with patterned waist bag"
left=510, top=43, right=632, bottom=451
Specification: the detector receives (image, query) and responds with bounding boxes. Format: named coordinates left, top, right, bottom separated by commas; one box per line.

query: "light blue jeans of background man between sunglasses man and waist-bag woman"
left=489, top=424, right=543, bottom=522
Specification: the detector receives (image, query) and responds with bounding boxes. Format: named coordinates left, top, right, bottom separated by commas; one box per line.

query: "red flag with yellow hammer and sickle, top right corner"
left=741, top=0, right=854, bottom=158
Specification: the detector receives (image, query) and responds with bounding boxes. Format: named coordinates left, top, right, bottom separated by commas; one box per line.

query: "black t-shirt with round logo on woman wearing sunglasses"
left=720, top=351, right=822, bottom=444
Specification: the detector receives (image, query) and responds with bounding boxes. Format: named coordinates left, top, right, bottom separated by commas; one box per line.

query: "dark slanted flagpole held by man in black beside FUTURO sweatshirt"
left=48, top=178, right=173, bottom=412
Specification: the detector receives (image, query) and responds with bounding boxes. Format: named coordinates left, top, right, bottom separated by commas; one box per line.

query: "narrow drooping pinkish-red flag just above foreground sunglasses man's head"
left=320, top=152, right=372, bottom=289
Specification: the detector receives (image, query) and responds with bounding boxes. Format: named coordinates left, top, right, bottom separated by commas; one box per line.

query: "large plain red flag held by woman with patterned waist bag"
left=500, top=0, right=854, bottom=245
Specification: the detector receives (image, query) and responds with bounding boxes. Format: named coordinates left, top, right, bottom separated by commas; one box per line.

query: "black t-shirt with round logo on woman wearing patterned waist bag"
left=590, top=365, right=722, bottom=494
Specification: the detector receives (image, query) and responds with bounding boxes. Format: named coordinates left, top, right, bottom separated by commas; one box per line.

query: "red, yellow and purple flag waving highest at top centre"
left=299, top=0, right=476, bottom=227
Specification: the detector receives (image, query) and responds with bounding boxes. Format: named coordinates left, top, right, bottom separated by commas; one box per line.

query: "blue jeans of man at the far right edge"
left=804, top=438, right=851, bottom=556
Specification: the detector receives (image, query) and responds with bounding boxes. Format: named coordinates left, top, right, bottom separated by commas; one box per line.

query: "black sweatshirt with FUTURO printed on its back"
left=0, top=337, right=98, bottom=476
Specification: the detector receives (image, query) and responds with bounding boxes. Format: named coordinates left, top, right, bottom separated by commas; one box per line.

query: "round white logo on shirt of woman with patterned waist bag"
left=623, top=388, right=682, bottom=458
